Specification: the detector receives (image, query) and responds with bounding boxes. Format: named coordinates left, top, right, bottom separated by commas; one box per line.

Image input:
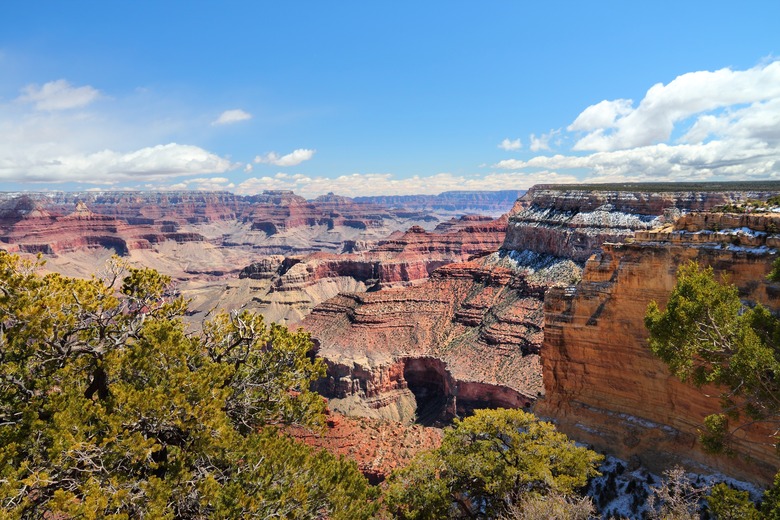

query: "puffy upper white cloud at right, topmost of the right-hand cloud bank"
left=568, top=61, right=780, bottom=152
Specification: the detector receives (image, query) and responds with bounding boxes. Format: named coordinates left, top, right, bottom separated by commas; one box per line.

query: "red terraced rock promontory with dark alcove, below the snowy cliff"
left=301, top=254, right=564, bottom=422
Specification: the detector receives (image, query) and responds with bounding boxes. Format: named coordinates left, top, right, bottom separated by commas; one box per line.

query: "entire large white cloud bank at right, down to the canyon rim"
left=494, top=61, right=780, bottom=182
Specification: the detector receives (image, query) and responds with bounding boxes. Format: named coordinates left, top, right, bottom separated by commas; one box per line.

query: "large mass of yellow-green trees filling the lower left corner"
left=0, top=252, right=375, bottom=518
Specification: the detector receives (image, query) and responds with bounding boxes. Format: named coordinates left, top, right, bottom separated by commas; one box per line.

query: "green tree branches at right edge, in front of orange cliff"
left=645, top=262, right=780, bottom=451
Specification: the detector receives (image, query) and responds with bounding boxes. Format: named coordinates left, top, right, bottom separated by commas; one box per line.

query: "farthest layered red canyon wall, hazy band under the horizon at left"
left=0, top=191, right=448, bottom=258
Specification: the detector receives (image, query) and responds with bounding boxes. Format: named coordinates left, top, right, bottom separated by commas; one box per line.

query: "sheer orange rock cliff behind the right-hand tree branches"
left=536, top=210, right=780, bottom=483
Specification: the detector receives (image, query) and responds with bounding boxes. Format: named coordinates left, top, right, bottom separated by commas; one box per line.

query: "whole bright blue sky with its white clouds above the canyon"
left=0, top=0, right=780, bottom=197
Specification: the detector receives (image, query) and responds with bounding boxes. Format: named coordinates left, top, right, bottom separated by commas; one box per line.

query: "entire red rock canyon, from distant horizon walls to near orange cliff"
left=0, top=183, right=780, bottom=500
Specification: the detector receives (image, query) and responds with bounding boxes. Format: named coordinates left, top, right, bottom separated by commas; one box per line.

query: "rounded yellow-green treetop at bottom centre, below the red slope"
left=386, top=410, right=601, bottom=519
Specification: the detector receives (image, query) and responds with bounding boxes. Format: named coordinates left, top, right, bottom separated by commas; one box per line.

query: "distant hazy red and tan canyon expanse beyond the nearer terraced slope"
left=0, top=191, right=521, bottom=324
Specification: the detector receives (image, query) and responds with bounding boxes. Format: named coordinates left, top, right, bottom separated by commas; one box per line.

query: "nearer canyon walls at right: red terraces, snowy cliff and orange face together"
left=302, top=182, right=780, bottom=483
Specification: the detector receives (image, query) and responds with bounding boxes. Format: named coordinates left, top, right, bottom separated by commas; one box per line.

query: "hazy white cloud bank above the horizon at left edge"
left=0, top=79, right=236, bottom=186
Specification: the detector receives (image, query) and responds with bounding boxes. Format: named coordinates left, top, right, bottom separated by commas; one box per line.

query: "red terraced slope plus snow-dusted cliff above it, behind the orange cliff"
left=302, top=185, right=780, bottom=430
